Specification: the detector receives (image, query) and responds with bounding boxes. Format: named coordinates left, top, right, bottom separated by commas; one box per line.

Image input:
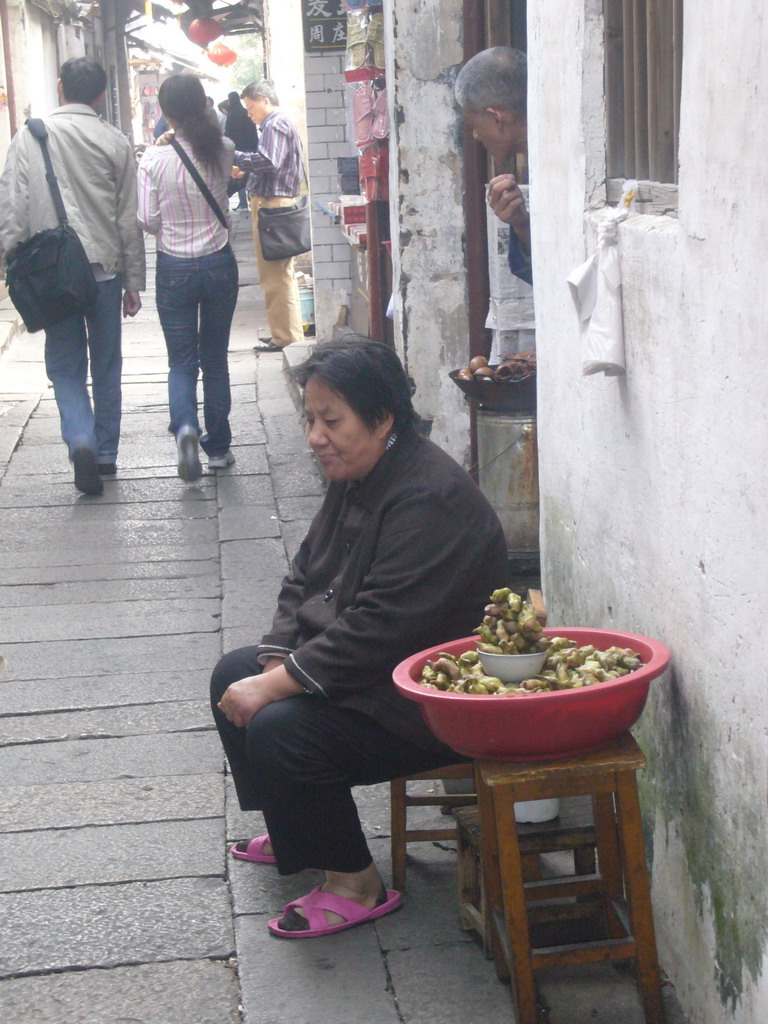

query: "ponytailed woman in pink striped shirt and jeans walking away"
left=138, top=75, right=238, bottom=480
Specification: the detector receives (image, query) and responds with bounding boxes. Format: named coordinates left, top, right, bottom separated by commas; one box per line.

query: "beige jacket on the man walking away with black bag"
left=0, top=103, right=146, bottom=292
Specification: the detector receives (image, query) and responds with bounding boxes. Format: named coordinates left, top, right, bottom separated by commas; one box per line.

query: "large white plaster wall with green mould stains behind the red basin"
left=528, top=0, right=768, bottom=1024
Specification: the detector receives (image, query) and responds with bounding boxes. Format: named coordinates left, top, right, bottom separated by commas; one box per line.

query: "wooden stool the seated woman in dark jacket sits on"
left=389, top=761, right=477, bottom=892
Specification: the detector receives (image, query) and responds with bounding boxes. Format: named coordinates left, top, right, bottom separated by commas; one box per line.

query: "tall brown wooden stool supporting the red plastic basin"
left=475, top=732, right=665, bottom=1024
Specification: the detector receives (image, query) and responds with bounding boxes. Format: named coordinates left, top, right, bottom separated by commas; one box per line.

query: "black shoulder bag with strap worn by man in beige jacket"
left=5, top=118, right=98, bottom=332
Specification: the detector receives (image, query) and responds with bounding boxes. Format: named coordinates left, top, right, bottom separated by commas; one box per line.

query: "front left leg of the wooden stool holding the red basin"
left=493, top=786, right=539, bottom=1024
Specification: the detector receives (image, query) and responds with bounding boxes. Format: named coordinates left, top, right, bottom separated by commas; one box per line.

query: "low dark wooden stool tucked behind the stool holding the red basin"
left=454, top=796, right=597, bottom=957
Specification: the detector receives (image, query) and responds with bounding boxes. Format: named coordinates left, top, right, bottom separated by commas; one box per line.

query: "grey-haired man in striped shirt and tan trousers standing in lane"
left=234, top=81, right=304, bottom=352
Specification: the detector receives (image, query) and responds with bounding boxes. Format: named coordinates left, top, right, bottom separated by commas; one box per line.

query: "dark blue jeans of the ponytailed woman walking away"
left=156, top=246, right=238, bottom=456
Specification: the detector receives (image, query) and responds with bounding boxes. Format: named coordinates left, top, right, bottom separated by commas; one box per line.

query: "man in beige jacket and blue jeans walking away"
left=0, top=57, right=145, bottom=495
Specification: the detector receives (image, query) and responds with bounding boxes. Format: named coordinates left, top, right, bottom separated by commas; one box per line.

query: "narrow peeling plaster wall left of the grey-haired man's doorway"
left=385, top=0, right=469, bottom=463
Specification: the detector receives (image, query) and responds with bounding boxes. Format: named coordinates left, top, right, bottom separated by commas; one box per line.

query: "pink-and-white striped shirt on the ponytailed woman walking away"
left=138, top=132, right=234, bottom=259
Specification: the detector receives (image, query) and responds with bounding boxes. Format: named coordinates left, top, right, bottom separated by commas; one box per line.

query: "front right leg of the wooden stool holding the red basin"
left=616, top=771, right=665, bottom=1024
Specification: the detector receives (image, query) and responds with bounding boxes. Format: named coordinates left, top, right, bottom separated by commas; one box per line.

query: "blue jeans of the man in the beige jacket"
left=45, top=274, right=123, bottom=463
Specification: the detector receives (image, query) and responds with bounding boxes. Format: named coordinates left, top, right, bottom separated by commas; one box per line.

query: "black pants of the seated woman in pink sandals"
left=211, top=647, right=462, bottom=874
